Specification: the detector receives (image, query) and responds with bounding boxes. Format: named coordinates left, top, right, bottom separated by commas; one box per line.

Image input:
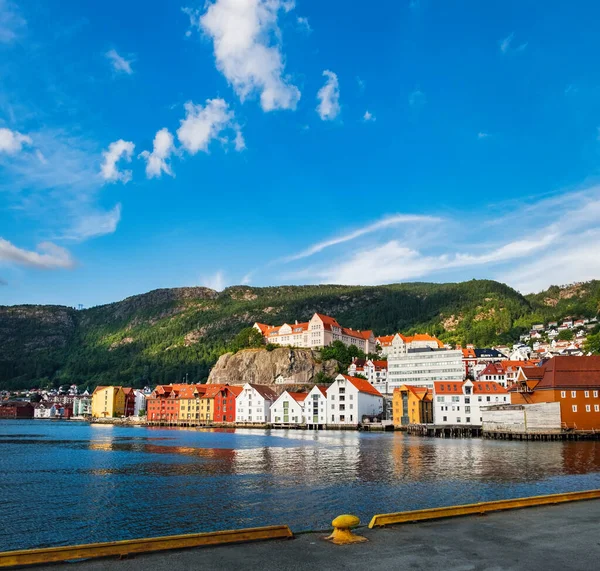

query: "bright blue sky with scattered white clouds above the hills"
left=0, top=0, right=600, bottom=306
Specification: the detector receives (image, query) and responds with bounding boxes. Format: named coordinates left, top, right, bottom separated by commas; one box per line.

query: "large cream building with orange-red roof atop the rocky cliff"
left=254, top=313, right=375, bottom=353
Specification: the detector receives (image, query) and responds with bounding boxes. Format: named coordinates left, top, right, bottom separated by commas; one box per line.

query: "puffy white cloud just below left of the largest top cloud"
left=177, top=99, right=246, bottom=155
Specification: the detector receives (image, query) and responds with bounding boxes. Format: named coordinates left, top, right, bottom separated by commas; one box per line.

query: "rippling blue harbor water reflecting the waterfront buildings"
left=0, top=420, right=600, bottom=551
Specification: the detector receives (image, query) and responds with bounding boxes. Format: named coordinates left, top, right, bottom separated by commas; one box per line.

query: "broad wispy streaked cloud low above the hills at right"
left=282, top=186, right=600, bottom=292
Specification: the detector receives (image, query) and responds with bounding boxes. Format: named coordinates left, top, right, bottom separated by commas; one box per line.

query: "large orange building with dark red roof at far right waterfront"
left=509, top=356, right=600, bottom=430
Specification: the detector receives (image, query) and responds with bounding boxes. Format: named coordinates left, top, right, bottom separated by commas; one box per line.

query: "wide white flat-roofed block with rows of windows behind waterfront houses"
left=388, top=349, right=465, bottom=392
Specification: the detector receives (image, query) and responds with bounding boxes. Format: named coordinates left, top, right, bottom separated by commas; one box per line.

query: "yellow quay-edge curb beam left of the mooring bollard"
left=0, top=525, right=294, bottom=567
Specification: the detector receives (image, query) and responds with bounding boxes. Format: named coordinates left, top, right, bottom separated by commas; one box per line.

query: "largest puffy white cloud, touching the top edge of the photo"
left=184, top=0, right=300, bottom=111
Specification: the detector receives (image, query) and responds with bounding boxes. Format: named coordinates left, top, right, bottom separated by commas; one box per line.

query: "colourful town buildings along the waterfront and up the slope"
left=0, top=313, right=600, bottom=439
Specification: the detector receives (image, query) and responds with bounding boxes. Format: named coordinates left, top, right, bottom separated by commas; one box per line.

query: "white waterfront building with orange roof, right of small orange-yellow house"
left=433, top=380, right=510, bottom=426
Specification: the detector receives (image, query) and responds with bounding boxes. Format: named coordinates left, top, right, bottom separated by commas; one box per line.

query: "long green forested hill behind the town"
left=0, top=280, right=600, bottom=389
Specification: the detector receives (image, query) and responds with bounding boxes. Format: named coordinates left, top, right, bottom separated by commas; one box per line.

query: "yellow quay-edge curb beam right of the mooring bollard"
left=369, top=490, right=600, bottom=528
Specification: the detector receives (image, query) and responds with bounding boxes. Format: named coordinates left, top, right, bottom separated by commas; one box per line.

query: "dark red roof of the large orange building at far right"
left=535, top=355, right=600, bottom=390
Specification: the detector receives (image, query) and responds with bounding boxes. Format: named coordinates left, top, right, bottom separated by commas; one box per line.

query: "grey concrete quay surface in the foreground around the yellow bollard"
left=23, top=500, right=600, bottom=571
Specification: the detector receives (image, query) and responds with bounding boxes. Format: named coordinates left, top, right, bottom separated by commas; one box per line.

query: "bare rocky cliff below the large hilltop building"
left=208, top=348, right=338, bottom=385
